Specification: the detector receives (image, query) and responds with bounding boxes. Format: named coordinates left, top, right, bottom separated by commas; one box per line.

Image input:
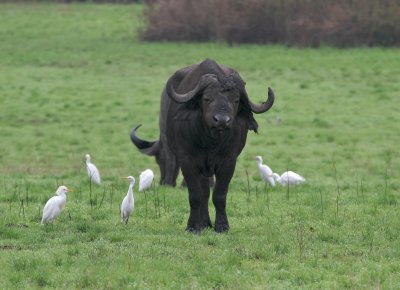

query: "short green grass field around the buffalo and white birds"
left=0, top=4, right=400, bottom=289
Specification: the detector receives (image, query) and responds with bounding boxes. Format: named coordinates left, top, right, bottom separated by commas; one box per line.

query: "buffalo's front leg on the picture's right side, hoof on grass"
left=213, top=162, right=236, bottom=233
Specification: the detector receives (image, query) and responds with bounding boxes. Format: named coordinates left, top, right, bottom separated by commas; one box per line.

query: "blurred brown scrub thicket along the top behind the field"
left=142, top=0, right=400, bottom=47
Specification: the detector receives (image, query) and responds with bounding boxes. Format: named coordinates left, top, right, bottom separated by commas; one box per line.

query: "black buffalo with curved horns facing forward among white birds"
left=131, top=59, right=274, bottom=232
